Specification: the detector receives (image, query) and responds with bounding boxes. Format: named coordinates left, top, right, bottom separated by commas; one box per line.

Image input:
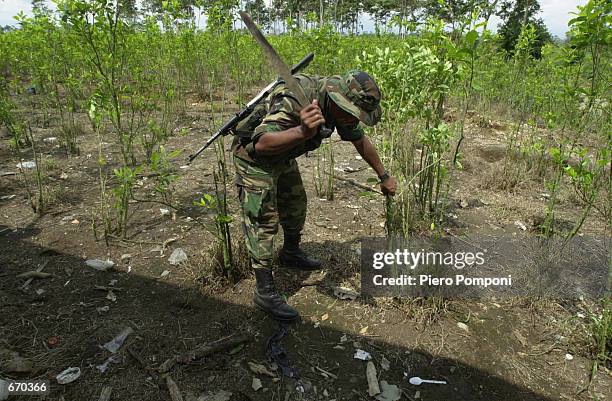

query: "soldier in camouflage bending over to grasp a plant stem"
left=232, top=70, right=396, bottom=321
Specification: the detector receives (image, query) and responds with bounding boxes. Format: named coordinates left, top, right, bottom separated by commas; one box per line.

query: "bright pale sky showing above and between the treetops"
left=0, top=0, right=587, bottom=38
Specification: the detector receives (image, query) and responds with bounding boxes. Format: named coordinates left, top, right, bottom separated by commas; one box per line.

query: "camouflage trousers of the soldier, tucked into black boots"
left=233, top=156, right=307, bottom=269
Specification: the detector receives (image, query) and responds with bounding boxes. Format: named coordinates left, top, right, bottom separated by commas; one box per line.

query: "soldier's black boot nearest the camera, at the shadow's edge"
left=253, top=269, right=300, bottom=322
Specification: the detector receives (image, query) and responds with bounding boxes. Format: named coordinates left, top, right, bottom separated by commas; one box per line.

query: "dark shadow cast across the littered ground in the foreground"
left=0, top=226, right=550, bottom=401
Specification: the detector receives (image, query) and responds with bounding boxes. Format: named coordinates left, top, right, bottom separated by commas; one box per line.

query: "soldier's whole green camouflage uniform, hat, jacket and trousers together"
left=233, top=71, right=380, bottom=269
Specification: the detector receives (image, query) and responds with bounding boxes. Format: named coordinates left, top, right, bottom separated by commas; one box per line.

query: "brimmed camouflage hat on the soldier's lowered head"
left=325, top=70, right=382, bottom=126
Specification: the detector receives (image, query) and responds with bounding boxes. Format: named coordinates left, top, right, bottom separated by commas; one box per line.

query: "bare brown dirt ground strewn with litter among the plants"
left=0, top=90, right=612, bottom=401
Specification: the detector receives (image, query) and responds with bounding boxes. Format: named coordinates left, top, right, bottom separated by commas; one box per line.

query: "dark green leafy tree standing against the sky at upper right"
left=497, top=0, right=552, bottom=59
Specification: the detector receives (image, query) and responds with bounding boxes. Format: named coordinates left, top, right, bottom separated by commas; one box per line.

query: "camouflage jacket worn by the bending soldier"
left=233, top=74, right=364, bottom=165
